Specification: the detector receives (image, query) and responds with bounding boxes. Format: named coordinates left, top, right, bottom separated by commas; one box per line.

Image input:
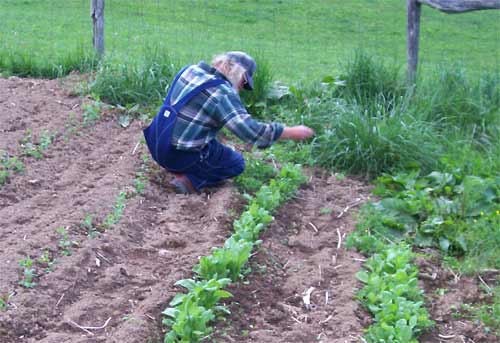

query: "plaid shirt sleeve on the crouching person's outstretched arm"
left=216, top=92, right=284, bottom=148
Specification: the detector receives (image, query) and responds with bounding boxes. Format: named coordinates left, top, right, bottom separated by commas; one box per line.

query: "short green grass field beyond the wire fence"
left=0, top=0, right=500, bottom=82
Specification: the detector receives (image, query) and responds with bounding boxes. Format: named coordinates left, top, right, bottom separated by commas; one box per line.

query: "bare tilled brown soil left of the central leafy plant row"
left=0, top=78, right=240, bottom=343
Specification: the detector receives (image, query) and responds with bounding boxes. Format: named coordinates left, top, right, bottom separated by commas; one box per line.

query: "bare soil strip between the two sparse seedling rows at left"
left=0, top=121, right=143, bottom=292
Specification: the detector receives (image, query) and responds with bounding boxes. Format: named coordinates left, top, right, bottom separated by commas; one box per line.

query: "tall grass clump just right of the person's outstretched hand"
left=313, top=99, right=441, bottom=178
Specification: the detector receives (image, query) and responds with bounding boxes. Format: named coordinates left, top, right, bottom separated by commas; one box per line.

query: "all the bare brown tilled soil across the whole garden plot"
left=0, top=78, right=494, bottom=343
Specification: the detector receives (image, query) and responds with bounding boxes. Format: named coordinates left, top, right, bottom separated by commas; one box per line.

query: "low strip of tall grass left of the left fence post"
left=0, top=44, right=98, bottom=79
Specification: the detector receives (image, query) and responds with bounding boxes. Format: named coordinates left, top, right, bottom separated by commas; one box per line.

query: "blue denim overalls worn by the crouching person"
left=144, top=67, right=245, bottom=190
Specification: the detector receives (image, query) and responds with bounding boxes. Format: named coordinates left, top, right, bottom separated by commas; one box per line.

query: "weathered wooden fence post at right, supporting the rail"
left=406, top=0, right=422, bottom=84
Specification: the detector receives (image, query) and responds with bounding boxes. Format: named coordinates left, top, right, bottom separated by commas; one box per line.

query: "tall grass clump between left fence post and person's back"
left=89, top=49, right=179, bottom=105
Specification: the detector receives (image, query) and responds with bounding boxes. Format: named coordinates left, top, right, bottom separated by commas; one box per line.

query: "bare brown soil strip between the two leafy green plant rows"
left=213, top=174, right=370, bottom=343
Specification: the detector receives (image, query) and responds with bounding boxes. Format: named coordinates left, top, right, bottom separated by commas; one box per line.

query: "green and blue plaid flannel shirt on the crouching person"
left=171, top=62, right=283, bottom=150
